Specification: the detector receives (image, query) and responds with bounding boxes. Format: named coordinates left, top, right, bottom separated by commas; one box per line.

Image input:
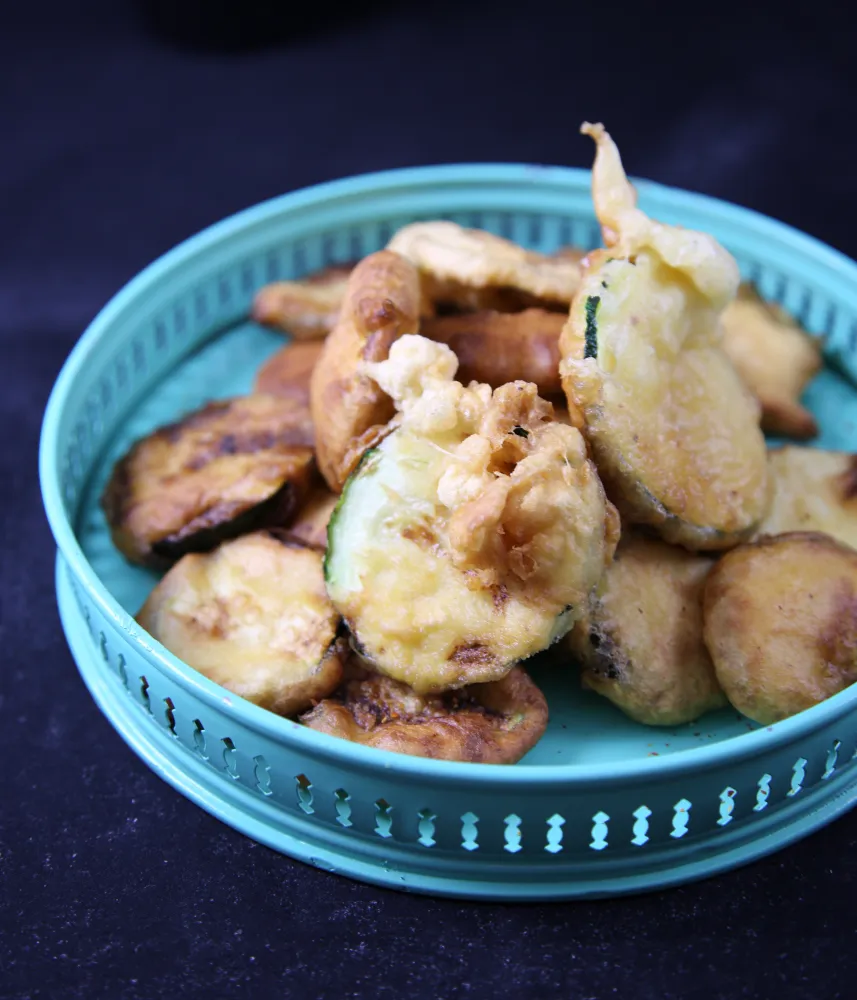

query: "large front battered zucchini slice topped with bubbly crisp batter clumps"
left=325, top=336, right=618, bottom=694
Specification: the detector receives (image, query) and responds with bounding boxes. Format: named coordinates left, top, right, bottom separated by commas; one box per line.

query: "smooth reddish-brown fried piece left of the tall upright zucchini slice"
left=420, top=309, right=565, bottom=396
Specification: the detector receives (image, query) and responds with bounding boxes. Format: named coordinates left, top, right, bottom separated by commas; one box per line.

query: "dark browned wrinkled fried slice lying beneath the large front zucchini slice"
left=300, top=658, right=548, bottom=764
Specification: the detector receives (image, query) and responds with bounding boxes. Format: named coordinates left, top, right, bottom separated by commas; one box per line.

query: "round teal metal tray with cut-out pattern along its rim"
left=41, top=166, right=857, bottom=899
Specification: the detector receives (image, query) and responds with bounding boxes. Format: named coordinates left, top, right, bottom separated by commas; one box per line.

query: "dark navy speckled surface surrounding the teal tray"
left=5, top=0, right=857, bottom=1000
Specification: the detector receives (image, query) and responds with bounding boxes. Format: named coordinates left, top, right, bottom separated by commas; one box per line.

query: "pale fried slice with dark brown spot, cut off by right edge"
left=759, top=445, right=857, bottom=549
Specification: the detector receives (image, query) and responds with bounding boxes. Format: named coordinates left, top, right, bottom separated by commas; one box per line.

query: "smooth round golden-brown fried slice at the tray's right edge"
left=704, top=531, right=857, bottom=725
